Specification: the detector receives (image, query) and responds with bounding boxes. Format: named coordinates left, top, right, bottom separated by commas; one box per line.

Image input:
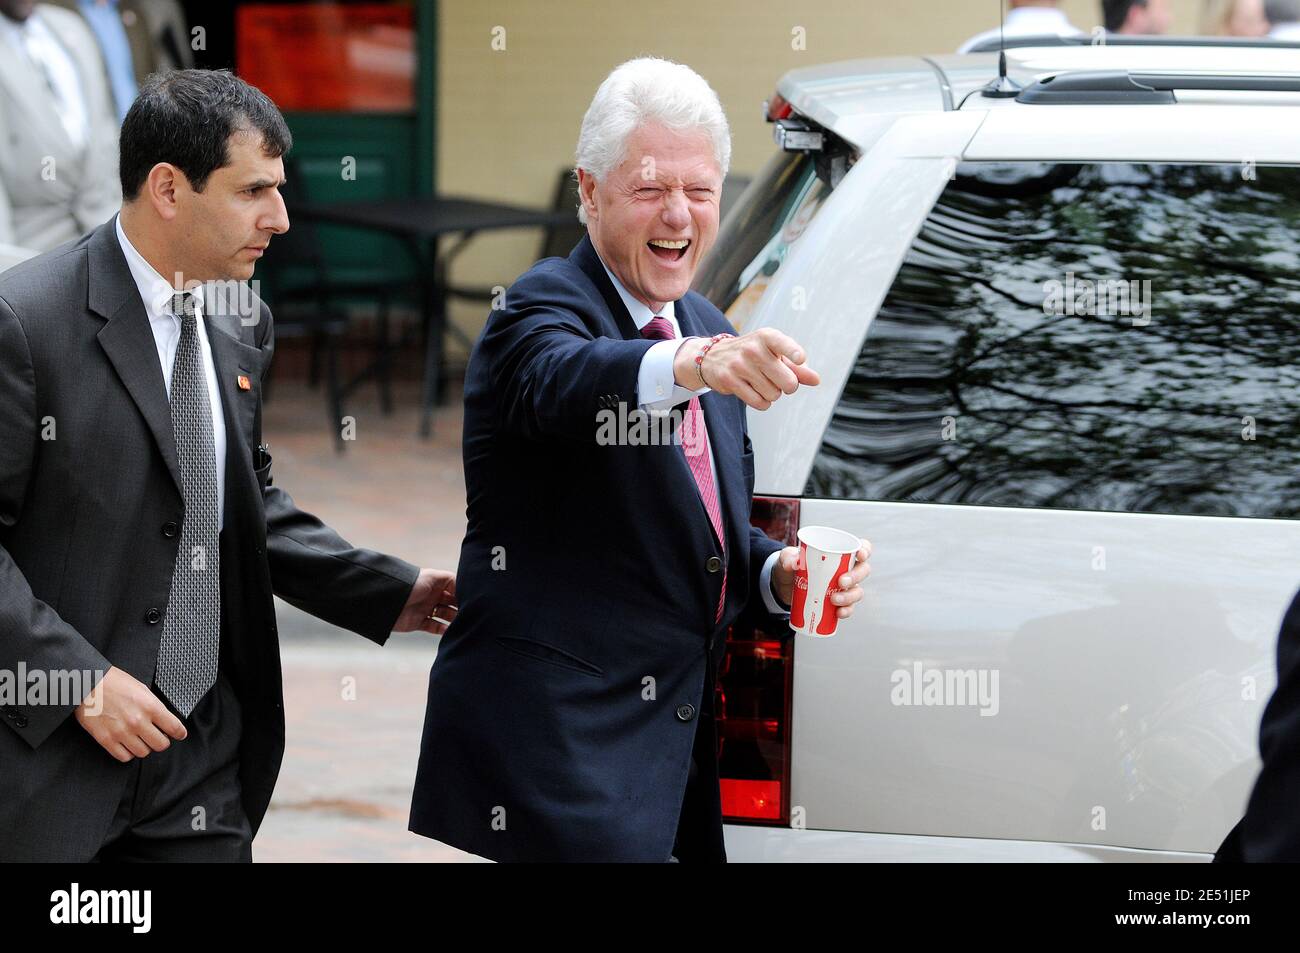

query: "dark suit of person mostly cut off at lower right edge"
left=1214, top=593, right=1300, bottom=863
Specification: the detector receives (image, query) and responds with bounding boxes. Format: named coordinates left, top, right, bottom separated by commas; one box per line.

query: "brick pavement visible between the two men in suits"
left=254, top=381, right=481, bottom=862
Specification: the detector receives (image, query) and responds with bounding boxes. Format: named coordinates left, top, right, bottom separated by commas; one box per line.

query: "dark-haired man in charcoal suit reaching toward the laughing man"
left=0, top=70, right=454, bottom=861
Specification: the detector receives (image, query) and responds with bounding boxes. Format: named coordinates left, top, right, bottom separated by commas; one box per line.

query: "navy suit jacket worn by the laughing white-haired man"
left=411, top=237, right=780, bottom=861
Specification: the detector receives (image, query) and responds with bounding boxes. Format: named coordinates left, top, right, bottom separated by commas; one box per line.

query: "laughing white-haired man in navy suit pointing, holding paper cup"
left=411, top=59, right=867, bottom=862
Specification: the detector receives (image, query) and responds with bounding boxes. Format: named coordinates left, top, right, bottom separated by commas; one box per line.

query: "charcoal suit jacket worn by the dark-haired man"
left=0, top=221, right=417, bottom=861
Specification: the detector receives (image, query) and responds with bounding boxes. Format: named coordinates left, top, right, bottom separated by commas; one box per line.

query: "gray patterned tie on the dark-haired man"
left=153, top=291, right=221, bottom=716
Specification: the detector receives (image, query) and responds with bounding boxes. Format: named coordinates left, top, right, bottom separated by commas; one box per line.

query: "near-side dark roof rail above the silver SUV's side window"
left=1015, top=70, right=1300, bottom=105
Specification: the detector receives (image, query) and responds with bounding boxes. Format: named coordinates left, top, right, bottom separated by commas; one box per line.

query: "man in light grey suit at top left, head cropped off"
left=0, top=0, right=122, bottom=252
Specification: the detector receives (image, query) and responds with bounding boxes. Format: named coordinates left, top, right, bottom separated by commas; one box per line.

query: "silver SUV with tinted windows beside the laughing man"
left=697, top=39, right=1300, bottom=861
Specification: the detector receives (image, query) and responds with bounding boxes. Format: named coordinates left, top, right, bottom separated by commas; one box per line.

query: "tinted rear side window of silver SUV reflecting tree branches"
left=807, top=163, right=1300, bottom=519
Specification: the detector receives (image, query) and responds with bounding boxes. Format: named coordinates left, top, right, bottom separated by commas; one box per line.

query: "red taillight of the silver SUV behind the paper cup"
left=714, top=497, right=800, bottom=824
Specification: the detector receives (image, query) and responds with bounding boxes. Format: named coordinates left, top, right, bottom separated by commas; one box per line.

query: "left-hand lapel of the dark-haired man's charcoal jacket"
left=87, top=216, right=181, bottom=491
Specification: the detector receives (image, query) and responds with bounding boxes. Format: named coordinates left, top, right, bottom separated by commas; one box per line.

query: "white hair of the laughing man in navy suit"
left=573, top=56, right=731, bottom=225
